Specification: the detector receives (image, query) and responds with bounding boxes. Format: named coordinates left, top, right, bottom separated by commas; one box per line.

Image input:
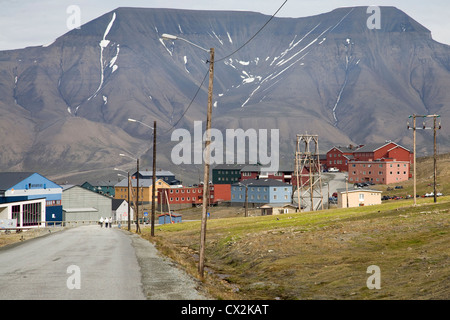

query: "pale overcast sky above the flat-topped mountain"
left=0, top=0, right=450, bottom=50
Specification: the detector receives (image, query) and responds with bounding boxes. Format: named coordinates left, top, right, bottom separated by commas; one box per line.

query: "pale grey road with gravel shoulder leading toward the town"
left=0, top=225, right=204, bottom=300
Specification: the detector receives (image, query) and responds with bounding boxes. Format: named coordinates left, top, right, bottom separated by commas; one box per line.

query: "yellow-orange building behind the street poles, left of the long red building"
left=114, top=179, right=170, bottom=204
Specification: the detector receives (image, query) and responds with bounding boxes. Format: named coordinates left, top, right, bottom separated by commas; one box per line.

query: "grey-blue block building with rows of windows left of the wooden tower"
left=231, top=179, right=292, bottom=206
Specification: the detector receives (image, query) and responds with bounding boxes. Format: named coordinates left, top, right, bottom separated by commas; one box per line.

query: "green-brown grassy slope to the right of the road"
left=142, top=197, right=450, bottom=299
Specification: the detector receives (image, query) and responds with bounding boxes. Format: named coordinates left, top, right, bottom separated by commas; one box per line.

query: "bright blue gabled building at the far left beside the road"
left=0, top=172, right=63, bottom=222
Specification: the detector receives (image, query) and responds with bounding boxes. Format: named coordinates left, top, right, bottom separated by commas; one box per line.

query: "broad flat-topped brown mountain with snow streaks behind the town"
left=0, top=7, right=450, bottom=182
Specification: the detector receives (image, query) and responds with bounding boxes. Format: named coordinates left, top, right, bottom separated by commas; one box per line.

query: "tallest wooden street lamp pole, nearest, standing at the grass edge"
left=161, top=33, right=214, bottom=278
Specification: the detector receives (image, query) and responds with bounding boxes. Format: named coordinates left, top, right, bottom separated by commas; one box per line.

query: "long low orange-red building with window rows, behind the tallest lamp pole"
left=158, top=184, right=231, bottom=211
